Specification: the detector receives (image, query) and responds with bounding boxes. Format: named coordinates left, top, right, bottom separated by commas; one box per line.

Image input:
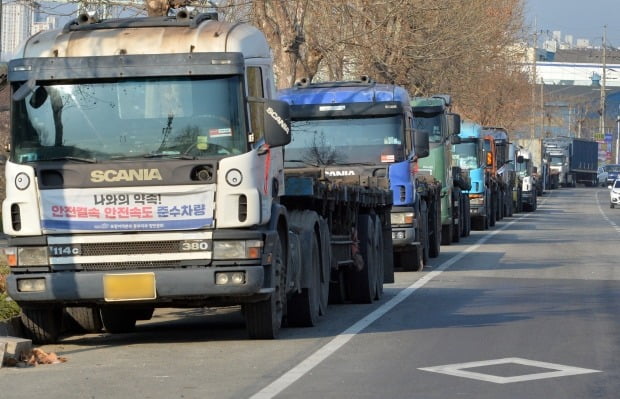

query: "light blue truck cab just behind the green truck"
left=452, top=121, right=490, bottom=229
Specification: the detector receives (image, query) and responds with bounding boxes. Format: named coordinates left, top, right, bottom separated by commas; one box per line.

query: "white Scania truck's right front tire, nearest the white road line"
left=245, top=233, right=286, bottom=339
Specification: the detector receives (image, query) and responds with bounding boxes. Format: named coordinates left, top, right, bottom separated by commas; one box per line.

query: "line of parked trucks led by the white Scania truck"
left=2, top=12, right=537, bottom=343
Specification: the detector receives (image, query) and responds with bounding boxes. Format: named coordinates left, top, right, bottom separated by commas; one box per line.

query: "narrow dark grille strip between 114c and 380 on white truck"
left=80, top=240, right=181, bottom=256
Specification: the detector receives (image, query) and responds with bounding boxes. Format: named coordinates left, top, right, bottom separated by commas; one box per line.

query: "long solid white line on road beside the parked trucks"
left=250, top=197, right=549, bottom=399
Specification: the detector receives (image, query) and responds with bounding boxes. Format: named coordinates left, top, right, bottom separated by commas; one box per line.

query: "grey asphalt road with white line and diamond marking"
left=0, top=188, right=620, bottom=399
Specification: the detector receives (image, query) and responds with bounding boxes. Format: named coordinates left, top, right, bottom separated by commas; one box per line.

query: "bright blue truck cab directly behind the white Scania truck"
left=277, top=77, right=428, bottom=272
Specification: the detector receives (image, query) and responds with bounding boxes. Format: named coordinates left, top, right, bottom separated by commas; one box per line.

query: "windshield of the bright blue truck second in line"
left=285, top=115, right=405, bottom=166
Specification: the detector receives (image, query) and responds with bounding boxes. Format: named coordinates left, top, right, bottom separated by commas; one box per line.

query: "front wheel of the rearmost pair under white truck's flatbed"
left=348, top=215, right=376, bottom=303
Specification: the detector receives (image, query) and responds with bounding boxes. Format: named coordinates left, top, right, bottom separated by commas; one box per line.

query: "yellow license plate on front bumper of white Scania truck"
left=103, top=273, right=156, bottom=302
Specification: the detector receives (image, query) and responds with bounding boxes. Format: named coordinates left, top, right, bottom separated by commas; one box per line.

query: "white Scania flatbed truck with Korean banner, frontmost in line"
left=2, top=10, right=391, bottom=343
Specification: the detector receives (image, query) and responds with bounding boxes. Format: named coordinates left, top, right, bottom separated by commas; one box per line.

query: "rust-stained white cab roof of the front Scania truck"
left=14, top=14, right=271, bottom=61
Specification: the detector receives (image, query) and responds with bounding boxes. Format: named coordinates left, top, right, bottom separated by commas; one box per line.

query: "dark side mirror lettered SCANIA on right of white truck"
left=256, top=99, right=291, bottom=147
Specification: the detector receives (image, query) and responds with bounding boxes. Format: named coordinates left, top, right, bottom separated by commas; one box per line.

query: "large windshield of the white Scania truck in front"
left=12, top=76, right=247, bottom=163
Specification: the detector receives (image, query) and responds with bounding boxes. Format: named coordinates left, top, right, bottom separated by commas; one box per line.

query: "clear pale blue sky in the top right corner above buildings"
left=525, top=0, right=620, bottom=48
